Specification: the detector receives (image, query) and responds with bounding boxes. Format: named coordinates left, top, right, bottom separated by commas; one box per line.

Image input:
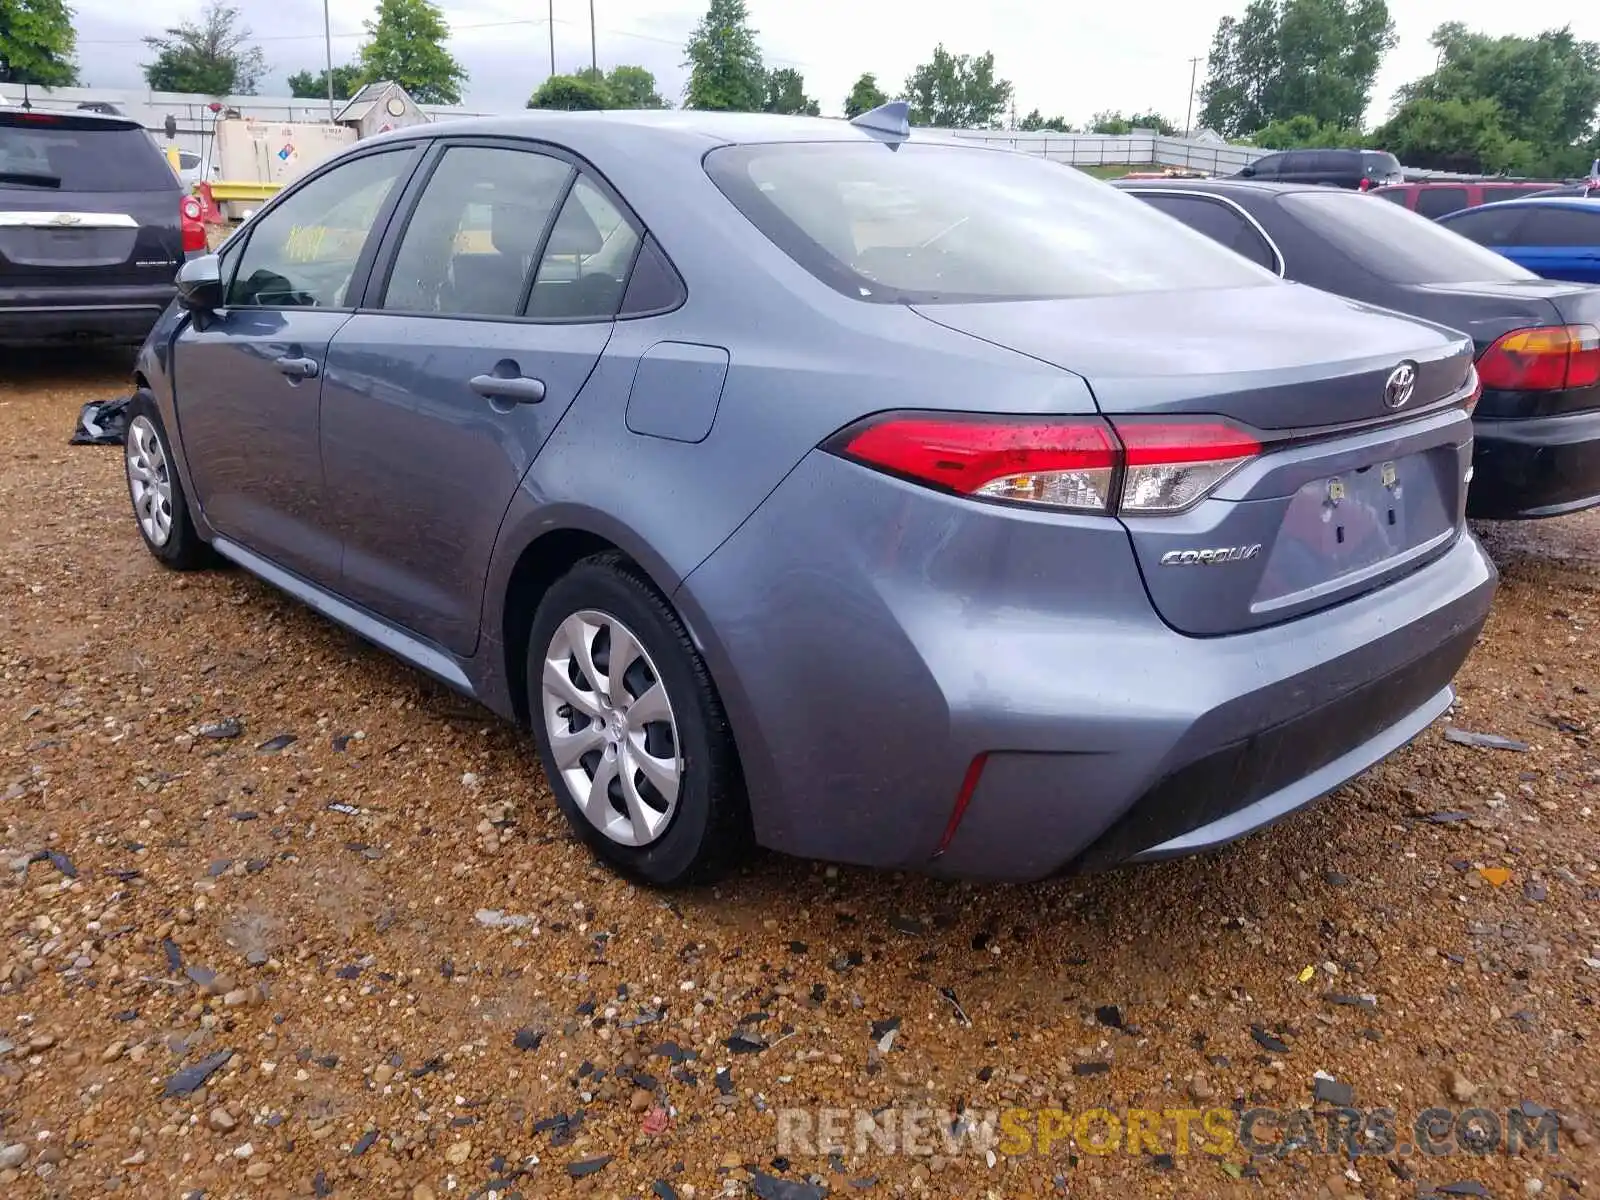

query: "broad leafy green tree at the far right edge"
left=1384, top=22, right=1600, bottom=174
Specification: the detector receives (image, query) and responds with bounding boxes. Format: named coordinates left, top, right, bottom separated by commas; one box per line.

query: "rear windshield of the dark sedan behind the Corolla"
left=1280, top=192, right=1538, bottom=283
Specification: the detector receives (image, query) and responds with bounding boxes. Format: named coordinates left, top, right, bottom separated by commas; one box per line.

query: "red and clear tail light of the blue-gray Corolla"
left=824, top=413, right=1261, bottom=515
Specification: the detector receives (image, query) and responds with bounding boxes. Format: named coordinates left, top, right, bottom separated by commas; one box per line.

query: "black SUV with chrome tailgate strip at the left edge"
left=0, top=109, right=184, bottom=346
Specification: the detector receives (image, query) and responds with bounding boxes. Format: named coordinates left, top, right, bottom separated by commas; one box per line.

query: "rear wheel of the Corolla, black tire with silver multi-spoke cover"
left=528, top=554, right=750, bottom=888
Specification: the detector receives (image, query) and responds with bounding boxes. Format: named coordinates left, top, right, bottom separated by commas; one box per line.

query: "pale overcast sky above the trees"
left=69, top=0, right=1600, bottom=125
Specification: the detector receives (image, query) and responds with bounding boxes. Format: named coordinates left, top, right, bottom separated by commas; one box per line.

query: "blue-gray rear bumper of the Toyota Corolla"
left=677, top=454, right=1496, bottom=880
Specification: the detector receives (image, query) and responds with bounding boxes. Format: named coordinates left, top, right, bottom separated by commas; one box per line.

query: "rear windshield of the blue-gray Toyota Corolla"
left=706, top=142, right=1278, bottom=304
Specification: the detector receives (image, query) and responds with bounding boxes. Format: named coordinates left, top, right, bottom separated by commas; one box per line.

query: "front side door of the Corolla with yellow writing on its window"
left=173, top=144, right=419, bottom=587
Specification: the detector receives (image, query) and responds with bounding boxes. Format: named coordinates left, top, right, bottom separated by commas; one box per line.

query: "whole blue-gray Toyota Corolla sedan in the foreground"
left=126, top=106, right=1494, bottom=885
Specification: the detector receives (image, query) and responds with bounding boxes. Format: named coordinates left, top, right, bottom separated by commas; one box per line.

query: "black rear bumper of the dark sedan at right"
left=1467, top=411, right=1600, bottom=520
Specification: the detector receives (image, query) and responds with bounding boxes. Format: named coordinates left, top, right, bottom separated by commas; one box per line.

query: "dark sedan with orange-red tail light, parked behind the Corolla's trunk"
left=1131, top=181, right=1600, bottom=518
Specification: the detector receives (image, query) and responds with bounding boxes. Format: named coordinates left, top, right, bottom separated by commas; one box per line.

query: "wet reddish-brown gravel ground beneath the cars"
left=0, top=357, right=1600, bottom=1200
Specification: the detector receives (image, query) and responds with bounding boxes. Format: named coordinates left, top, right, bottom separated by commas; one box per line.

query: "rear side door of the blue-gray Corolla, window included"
left=322, top=139, right=640, bottom=656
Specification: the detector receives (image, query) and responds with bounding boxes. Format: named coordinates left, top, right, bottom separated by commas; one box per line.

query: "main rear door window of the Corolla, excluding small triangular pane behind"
left=379, top=146, right=573, bottom=317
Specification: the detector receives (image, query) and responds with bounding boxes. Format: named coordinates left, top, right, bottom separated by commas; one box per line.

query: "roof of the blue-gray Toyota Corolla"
left=363, top=109, right=947, bottom=150
